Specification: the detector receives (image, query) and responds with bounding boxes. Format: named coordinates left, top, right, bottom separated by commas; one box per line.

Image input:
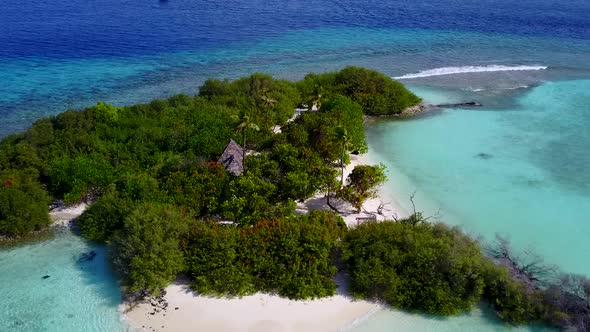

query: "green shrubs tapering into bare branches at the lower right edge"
left=342, top=215, right=590, bottom=331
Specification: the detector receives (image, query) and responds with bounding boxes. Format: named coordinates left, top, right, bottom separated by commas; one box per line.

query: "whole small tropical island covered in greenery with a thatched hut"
left=0, top=67, right=590, bottom=331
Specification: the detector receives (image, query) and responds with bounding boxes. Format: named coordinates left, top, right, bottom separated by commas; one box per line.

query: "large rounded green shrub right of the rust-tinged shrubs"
left=343, top=222, right=484, bottom=315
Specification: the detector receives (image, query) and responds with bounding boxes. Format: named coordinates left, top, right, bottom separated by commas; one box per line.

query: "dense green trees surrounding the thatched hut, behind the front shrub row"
left=0, top=67, right=419, bottom=241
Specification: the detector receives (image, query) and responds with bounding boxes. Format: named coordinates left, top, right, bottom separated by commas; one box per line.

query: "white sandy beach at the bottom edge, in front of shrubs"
left=125, top=276, right=380, bottom=332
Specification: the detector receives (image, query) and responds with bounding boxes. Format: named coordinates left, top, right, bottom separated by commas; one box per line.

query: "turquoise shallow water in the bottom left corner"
left=0, top=231, right=131, bottom=332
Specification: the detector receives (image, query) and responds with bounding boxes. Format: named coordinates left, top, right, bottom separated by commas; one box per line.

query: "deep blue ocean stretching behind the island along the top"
left=0, top=0, right=590, bottom=136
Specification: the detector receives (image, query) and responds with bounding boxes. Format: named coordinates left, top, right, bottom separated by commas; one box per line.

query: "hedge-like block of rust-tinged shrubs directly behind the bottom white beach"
left=185, top=211, right=346, bottom=299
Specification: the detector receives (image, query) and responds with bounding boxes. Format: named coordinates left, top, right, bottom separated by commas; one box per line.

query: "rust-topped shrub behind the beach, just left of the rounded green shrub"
left=243, top=218, right=336, bottom=299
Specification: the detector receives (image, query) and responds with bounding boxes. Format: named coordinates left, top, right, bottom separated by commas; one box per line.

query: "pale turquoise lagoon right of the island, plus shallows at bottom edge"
left=353, top=80, right=590, bottom=332
